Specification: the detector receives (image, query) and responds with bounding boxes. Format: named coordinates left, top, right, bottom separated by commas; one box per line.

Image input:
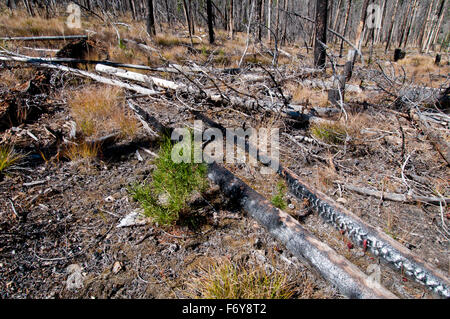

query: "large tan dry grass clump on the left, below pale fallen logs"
left=68, top=86, right=139, bottom=138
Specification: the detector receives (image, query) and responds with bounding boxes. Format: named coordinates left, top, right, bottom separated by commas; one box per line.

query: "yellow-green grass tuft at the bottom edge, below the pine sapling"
left=190, top=261, right=294, bottom=299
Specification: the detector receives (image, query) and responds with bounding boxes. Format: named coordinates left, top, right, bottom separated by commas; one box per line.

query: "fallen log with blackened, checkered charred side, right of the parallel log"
left=195, top=112, right=450, bottom=298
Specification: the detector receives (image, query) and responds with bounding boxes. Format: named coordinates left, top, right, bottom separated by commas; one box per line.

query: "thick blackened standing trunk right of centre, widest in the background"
left=314, top=0, right=328, bottom=68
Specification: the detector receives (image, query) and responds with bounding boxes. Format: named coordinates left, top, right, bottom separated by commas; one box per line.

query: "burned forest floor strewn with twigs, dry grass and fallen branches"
left=0, top=10, right=450, bottom=299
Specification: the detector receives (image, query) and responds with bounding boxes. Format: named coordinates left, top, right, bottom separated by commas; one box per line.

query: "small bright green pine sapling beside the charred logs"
left=130, top=138, right=207, bottom=226
